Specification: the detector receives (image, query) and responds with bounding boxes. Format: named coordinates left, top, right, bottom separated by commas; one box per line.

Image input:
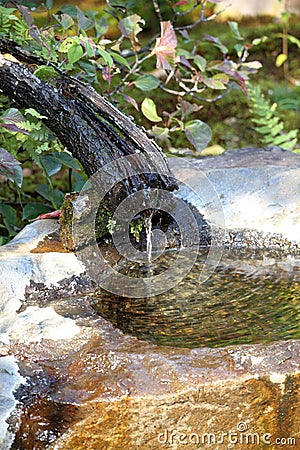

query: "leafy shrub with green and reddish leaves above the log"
left=3, top=0, right=259, bottom=152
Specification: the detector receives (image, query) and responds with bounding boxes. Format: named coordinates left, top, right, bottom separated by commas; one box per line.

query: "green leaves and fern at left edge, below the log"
left=0, top=97, right=81, bottom=241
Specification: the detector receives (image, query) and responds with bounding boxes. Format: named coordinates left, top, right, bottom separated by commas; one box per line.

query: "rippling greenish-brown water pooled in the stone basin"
left=93, top=252, right=300, bottom=348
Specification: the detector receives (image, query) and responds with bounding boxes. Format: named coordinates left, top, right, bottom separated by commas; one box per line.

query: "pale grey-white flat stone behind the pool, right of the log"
left=170, top=147, right=300, bottom=243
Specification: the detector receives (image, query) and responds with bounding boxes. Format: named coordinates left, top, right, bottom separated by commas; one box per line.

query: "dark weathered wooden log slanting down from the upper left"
left=0, top=39, right=177, bottom=206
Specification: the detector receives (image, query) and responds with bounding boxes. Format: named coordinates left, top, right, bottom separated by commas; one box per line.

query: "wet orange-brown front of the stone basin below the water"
left=12, top=326, right=300, bottom=450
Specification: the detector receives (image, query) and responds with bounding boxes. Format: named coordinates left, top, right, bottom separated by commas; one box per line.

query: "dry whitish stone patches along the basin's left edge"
left=0, top=220, right=82, bottom=450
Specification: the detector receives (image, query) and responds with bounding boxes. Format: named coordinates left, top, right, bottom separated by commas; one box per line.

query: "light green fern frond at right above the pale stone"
left=247, top=83, right=299, bottom=150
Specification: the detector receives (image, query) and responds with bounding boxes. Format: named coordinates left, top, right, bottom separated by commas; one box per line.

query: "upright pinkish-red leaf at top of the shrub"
left=152, top=21, right=177, bottom=70
